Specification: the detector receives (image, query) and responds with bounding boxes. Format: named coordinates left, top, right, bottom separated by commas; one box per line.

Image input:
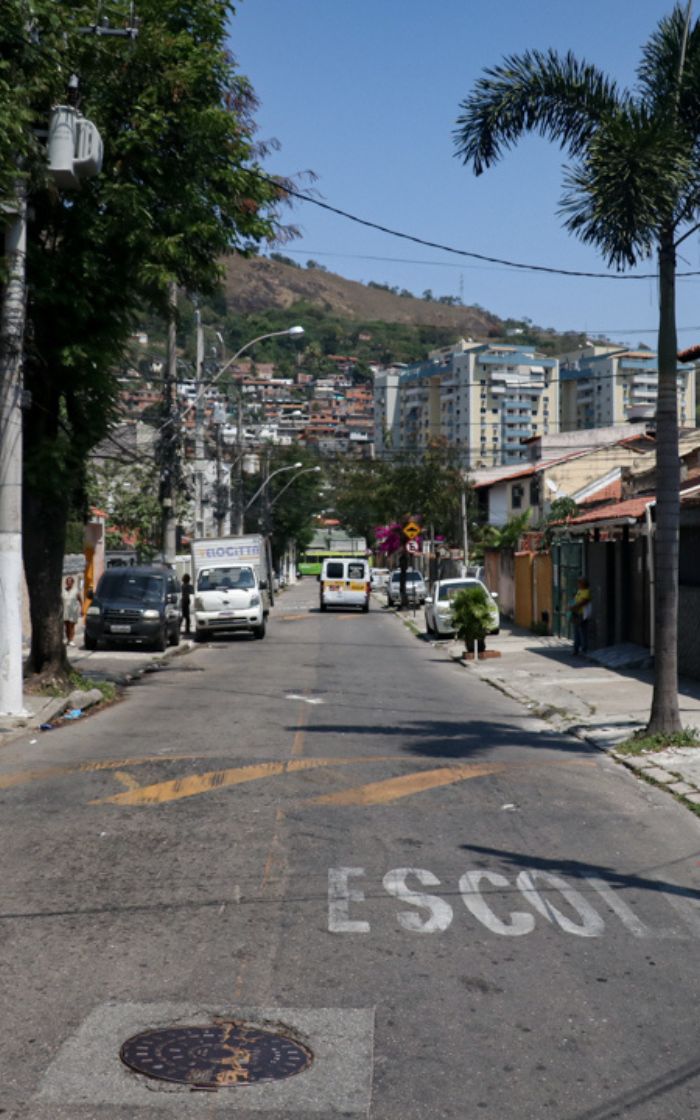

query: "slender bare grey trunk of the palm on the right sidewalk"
left=647, top=228, right=681, bottom=735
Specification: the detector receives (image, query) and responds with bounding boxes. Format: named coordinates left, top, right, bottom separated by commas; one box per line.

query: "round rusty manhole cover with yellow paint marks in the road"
left=120, top=1023, right=314, bottom=1089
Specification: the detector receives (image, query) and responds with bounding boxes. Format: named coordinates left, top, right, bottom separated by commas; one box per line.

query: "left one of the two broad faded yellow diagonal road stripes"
left=90, top=756, right=395, bottom=805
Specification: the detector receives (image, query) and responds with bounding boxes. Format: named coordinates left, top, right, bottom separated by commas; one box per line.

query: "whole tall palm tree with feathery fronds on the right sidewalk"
left=455, top=0, right=700, bottom=734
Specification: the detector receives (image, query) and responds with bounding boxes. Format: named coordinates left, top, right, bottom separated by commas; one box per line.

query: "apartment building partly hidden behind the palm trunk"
left=559, top=344, right=696, bottom=431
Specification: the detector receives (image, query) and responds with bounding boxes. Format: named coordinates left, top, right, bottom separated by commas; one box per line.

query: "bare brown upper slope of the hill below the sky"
left=224, top=256, right=503, bottom=338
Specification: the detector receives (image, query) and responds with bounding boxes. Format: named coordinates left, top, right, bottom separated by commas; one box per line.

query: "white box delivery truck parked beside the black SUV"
left=190, top=535, right=273, bottom=642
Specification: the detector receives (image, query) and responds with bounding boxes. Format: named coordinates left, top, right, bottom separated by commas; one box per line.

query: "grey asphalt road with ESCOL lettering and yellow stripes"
left=0, top=580, right=700, bottom=1120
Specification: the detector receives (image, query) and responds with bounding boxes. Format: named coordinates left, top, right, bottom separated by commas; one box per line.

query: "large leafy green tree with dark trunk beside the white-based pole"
left=0, top=0, right=284, bottom=672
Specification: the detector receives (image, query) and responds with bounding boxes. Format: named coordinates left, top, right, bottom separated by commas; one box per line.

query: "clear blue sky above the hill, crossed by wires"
left=230, top=0, right=700, bottom=346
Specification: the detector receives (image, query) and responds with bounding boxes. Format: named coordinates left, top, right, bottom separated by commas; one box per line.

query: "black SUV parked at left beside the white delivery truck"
left=85, top=566, right=181, bottom=651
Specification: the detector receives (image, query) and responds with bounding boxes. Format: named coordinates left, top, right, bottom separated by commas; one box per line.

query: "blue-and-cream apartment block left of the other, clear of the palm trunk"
left=374, top=338, right=559, bottom=467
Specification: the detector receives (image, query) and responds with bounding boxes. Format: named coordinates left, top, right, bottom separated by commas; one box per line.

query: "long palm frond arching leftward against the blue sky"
left=455, top=50, right=626, bottom=175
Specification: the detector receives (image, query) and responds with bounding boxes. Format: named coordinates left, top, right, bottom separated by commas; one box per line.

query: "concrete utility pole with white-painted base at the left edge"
left=0, top=183, right=27, bottom=716
